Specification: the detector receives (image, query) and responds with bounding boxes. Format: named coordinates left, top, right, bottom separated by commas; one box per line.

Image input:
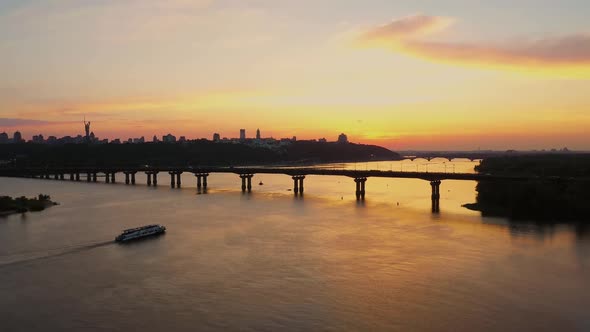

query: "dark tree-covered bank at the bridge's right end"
left=466, top=154, right=590, bottom=223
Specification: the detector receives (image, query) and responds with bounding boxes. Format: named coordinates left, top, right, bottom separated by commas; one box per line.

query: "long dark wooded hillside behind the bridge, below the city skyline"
left=0, top=140, right=401, bottom=167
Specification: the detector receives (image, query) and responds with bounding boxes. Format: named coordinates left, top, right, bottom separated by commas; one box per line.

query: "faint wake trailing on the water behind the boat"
left=0, top=240, right=115, bottom=268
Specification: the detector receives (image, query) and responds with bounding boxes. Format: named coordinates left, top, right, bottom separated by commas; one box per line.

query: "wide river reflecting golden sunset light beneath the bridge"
left=0, top=160, right=590, bottom=332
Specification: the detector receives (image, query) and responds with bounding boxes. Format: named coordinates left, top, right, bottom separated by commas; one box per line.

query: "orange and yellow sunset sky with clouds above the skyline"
left=0, top=0, right=590, bottom=150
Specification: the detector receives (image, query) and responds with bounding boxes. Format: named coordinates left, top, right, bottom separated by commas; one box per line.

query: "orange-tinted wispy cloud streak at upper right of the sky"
left=356, top=15, right=590, bottom=75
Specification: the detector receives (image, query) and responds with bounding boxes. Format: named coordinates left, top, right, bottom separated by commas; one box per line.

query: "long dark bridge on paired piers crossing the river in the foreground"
left=0, top=166, right=590, bottom=212
